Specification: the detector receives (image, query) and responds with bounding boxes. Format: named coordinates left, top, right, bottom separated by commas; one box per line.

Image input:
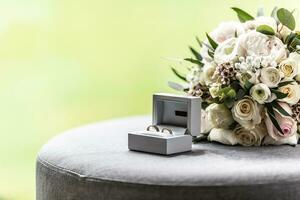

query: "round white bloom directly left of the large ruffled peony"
left=214, top=38, right=238, bottom=64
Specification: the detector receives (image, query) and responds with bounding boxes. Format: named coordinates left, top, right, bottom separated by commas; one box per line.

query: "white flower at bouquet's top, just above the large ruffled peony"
left=243, top=16, right=277, bottom=32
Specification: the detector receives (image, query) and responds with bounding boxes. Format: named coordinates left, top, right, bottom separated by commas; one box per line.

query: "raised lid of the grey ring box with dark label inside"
left=152, top=93, right=201, bottom=136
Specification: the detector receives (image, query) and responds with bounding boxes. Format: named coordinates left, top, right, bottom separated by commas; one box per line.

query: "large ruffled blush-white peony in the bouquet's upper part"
left=239, top=31, right=287, bottom=63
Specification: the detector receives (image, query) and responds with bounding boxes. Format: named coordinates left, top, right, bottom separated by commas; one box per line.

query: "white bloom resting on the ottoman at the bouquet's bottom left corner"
left=207, top=128, right=238, bottom=145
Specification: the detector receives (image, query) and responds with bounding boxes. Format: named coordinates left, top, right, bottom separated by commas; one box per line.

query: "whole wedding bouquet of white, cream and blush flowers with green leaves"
left=169, top=8, right=300, bottom=146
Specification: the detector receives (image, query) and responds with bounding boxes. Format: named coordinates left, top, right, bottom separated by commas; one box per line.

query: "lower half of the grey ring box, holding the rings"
left=128, top=132, right=192, bottom=155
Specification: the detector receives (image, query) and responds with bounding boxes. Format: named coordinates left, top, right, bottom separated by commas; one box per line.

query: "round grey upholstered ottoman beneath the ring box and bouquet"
left=36, top=117, right=300, bottom=200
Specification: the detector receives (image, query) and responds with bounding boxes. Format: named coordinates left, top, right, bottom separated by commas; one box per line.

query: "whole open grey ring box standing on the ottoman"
left=128, top=93, right=201, bottom=155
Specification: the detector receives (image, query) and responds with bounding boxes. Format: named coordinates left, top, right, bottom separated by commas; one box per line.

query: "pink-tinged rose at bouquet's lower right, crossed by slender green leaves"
left=265, top=102, right=297, bottom=141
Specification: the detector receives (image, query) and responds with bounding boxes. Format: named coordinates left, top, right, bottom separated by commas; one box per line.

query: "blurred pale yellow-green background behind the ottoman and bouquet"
left=0, top=0, right=300, bottom=200
